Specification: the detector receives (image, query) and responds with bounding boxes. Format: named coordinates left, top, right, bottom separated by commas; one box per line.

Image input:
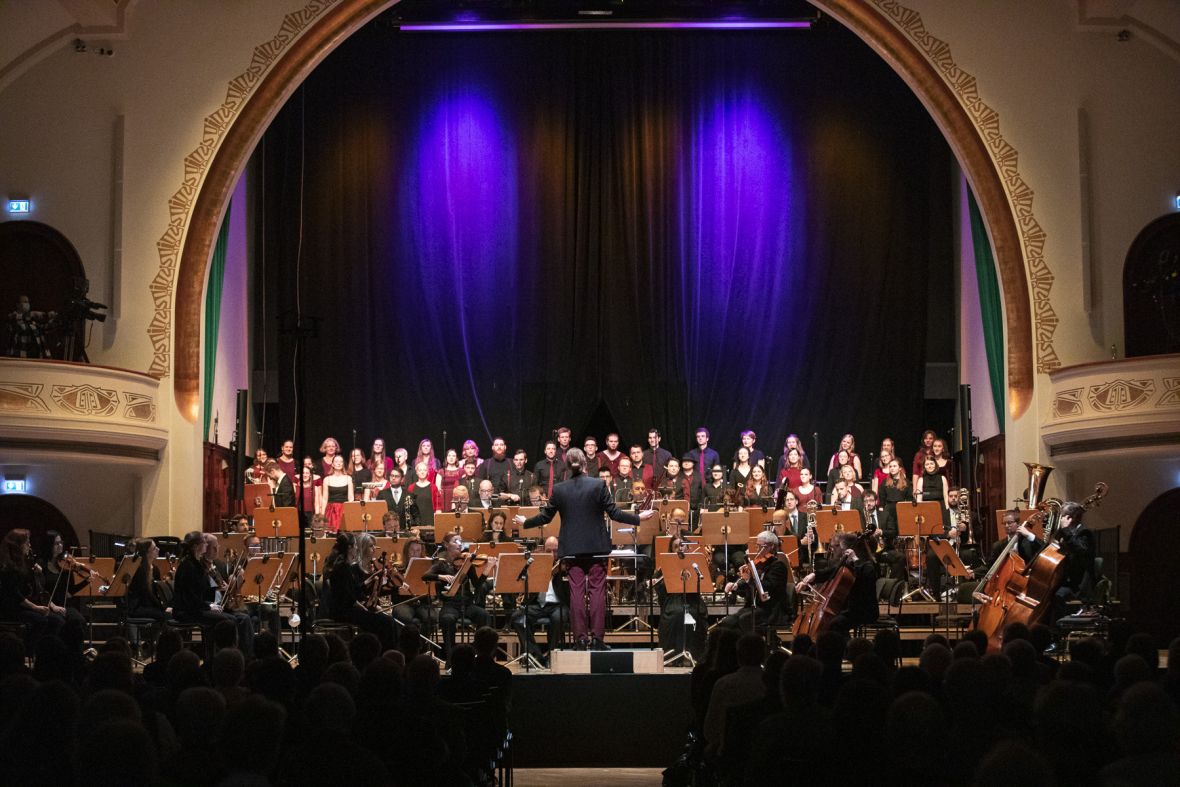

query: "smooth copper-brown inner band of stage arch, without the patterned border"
left=166, top=0, right=1033, bottom=421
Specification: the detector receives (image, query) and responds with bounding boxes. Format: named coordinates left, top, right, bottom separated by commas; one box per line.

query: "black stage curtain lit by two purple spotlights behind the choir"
left=255, top=27, right=953, bottom=459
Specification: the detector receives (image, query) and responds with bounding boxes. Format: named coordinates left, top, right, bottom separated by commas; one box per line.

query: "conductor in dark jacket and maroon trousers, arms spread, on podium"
left=513, top=448, right=655, bottom=650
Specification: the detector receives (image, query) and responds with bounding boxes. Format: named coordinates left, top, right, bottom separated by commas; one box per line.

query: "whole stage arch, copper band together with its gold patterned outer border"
left=159, top=0, right=1043, bottom=421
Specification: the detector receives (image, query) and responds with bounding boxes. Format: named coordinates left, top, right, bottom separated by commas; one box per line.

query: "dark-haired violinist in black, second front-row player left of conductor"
left=323, top=532, right=398, bottom=650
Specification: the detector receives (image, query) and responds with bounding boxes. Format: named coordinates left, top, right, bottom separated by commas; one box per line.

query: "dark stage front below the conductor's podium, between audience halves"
left=511, top=670, right=693, bottom=768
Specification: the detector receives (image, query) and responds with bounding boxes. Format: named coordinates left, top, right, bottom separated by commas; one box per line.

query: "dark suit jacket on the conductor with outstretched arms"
left=524, top=473, right=640, bottom=557
